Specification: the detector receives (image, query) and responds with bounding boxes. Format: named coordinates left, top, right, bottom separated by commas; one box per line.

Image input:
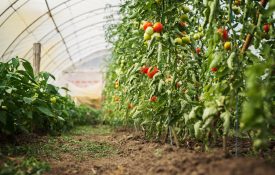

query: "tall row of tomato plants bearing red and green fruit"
left=103, top=0, right=275, bottom=149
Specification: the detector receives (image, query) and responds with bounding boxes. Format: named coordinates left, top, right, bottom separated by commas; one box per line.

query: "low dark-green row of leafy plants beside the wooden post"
left=0, top=57, right=99, bottom=135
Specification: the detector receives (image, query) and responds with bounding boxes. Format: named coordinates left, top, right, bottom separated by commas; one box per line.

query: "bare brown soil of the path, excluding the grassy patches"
left=39, top=126, right=275, bottom=175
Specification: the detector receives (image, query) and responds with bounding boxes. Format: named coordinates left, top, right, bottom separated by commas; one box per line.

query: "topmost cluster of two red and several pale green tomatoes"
left=141, top=21, right=163, bottom=41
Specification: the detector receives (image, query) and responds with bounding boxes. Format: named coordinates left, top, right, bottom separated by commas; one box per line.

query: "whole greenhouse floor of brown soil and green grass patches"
left=0, top=126, right=275, bottom=175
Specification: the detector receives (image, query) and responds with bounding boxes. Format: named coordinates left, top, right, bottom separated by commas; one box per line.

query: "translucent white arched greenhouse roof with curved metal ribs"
left=0, top=0, right=120, bottom=75
